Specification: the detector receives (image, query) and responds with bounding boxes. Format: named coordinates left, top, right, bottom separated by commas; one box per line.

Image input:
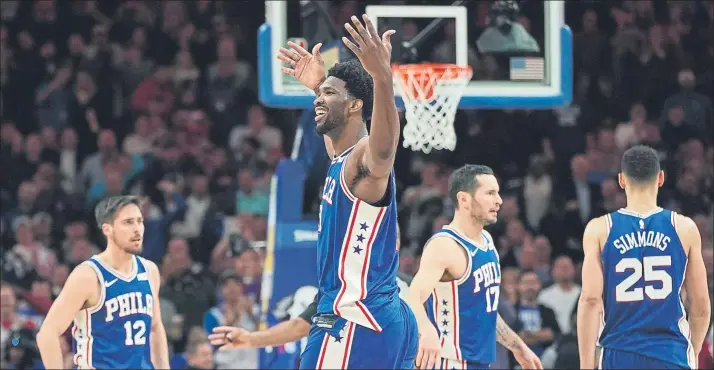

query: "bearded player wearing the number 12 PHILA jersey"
left=37, top=196, right=169, bottom=369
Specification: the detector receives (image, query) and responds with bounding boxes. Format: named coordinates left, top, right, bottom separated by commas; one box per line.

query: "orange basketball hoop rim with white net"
left=392, top=64, right=472, bottom=153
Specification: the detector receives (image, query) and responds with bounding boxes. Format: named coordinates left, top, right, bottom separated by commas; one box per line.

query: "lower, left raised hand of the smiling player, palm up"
left=278, top=41, right=325, bottom=90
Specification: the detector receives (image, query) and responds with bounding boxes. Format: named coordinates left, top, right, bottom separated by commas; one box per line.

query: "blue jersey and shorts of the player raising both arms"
left=300, top=147, right=418, bottom=369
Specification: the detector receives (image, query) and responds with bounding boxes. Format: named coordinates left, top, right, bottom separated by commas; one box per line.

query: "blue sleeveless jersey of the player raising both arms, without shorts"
left=317, top=147, right=401, bottom=332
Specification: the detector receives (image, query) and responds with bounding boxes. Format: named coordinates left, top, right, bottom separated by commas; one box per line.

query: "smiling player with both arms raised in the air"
left=278, top=15, right=417, bottom=369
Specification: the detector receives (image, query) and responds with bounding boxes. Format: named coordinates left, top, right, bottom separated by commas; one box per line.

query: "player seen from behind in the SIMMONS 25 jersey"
left=578, top=146, right=711, bottom=369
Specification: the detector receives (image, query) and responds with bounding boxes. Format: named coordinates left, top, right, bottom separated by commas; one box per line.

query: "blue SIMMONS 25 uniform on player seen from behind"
left=599, top=208, right=696, bottom=369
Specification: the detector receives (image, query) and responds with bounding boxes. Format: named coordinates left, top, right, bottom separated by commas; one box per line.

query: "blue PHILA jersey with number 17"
left=426, top=226, right=501, bottom=369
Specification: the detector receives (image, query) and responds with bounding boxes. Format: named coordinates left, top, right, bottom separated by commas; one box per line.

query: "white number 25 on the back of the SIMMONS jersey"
left=615, top=256, right=672, bottom=302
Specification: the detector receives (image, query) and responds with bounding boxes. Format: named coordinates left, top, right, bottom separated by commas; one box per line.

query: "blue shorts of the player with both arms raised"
left=300, top=301, right=419, bottom=370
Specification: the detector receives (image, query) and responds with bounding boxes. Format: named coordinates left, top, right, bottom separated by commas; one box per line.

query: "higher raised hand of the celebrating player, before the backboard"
left=342, top=14, right=396, bottom=79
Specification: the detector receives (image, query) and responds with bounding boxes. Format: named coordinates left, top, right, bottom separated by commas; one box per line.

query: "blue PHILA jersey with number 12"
left=72, top=256, right=154, bottom=369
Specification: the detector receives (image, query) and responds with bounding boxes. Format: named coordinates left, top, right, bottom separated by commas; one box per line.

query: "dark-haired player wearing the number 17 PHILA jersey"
left=400, top=165, right=542, bottom=369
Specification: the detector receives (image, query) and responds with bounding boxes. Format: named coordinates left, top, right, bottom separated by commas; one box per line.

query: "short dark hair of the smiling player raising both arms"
left=327, top=59, right=374, bottom=121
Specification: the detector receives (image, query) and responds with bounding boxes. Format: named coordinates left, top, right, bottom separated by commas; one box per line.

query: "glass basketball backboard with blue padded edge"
left=258, top=0, right=573, bottom=109
